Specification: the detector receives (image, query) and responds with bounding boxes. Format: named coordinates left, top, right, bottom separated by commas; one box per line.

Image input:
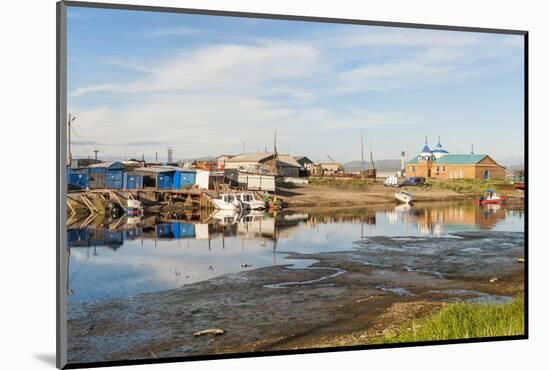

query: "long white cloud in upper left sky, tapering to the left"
left=71, top=43, right=323, bottom=97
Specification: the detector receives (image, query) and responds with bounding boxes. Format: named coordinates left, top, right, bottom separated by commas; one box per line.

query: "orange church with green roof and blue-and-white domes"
left=405, top=138, right=506, bottom=180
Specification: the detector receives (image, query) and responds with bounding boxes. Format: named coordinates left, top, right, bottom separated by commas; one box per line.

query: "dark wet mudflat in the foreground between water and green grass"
left=68, top=231, right=524, bottom=362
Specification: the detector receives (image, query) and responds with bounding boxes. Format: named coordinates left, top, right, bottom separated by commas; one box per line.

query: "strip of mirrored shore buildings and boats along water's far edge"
left=67, top=203, right=523, bottom=249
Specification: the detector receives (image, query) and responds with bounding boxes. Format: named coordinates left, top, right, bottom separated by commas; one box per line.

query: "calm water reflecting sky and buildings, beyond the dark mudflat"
left=67, top=203, right=524, bottom=302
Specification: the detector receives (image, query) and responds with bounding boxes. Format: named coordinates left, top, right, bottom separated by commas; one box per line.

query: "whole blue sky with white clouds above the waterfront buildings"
left=67, top=7, right=524, bottom=162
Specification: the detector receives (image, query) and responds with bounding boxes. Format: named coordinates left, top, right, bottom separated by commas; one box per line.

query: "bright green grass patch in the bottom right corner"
left=373, top=297, right=525, bottom=343
